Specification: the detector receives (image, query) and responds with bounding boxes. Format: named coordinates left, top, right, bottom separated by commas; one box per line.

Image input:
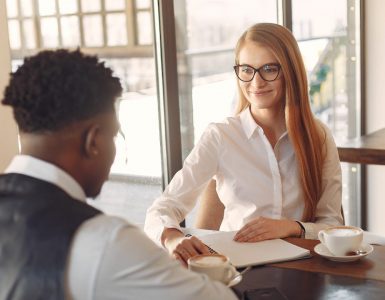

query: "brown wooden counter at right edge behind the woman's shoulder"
left=337, top=128, right=385, bottom=165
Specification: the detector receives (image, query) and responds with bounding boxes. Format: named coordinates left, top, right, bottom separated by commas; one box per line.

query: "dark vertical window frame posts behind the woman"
left=153, top=0, right=367, bottom=229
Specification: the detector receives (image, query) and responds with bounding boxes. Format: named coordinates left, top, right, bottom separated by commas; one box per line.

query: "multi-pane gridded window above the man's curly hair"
left=6, top=0, right=152, bottom=58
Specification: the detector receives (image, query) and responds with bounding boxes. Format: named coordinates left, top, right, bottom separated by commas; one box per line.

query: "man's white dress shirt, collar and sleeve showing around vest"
left=6, top=155, right=237, bottom=300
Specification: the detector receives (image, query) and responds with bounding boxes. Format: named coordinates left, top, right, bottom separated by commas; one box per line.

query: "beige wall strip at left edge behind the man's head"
left=0, top=0, right=18, bottom=173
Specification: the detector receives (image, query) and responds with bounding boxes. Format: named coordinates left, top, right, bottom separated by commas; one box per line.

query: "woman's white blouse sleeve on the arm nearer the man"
left=144, top=124, right=220, bottom=243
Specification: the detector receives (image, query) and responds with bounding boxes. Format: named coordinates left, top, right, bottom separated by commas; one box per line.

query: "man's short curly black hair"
left=2, top=49, right=122, bottom=133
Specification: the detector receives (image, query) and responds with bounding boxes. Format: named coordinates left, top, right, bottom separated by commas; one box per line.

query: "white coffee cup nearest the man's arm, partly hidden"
left=187, top=254, right=236, bottom=284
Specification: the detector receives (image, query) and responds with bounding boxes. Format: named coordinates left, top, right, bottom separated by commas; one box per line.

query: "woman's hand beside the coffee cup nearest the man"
left=162, top=228, right=210, bottom=267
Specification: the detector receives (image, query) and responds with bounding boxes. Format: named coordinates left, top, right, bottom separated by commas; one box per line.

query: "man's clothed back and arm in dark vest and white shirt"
left=0, top=155, right=234, bottom=300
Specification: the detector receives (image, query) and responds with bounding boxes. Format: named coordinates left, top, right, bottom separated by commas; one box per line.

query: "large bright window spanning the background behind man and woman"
left=6, top=0, right=361, bottom=225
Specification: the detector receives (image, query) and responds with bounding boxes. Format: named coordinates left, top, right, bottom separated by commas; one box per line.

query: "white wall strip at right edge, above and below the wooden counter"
left=365, top=0, right=385, bottom=234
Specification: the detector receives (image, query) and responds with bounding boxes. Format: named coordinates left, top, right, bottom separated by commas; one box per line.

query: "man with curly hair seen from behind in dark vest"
left=0, top=50, right=235, bottom=300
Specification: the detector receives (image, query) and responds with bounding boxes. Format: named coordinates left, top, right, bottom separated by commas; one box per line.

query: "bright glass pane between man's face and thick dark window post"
left=99, top=53, right=162, bottom=223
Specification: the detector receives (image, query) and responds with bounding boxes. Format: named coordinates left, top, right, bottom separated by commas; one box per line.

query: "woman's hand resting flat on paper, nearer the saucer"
left=234, top=217, right=301, bottom=243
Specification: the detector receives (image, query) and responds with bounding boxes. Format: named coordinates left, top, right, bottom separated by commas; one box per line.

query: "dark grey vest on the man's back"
left=0, top=174, right=100, bottom=300
